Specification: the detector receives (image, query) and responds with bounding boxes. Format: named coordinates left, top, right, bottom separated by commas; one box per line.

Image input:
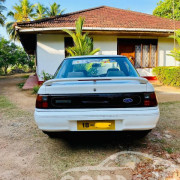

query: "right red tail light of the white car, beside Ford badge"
left=144, top=92, right=158, bottom=107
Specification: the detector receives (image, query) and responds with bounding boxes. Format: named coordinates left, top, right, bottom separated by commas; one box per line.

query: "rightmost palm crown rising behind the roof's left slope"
left=47, top=3, right=65, bottom=17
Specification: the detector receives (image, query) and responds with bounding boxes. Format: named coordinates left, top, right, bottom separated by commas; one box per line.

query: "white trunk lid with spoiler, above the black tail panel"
left=44, top=78, right=147, bottom=94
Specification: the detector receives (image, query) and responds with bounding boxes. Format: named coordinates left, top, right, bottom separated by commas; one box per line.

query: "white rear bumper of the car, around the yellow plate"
left=34, top=107, right=159, bottom=132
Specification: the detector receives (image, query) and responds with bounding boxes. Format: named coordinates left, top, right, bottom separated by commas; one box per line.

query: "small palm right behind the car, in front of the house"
left=63, top=17, right=100, bottom=56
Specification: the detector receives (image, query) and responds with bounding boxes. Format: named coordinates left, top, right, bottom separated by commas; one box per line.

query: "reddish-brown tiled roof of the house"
left=17, top=6, right=180, bottom=30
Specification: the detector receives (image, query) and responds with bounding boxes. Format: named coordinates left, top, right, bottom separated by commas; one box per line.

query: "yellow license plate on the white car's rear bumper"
left=77, top=121, right=115, bottom=130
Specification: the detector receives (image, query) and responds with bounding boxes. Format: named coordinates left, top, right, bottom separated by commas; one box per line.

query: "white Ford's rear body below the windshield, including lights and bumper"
left=35, top=56, right=159, bottom=132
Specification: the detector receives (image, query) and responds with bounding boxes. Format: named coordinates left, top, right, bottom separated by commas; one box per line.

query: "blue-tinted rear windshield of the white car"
left=54, top=57, right=138, bottom=79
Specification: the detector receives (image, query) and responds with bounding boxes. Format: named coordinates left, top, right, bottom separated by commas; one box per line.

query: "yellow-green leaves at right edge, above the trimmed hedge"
left=170, top=30, right=180, bottom=61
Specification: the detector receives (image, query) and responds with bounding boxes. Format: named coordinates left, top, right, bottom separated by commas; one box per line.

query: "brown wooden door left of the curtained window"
left=118, top=43, right=135, bottom=65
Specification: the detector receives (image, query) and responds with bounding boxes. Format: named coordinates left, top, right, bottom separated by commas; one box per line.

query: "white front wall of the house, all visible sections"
left=37, top=34, right=178, bottom=80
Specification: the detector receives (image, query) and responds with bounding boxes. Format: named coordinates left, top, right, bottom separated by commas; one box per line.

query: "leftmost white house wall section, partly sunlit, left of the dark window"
left=37, top=34, right=65, bottom=81
